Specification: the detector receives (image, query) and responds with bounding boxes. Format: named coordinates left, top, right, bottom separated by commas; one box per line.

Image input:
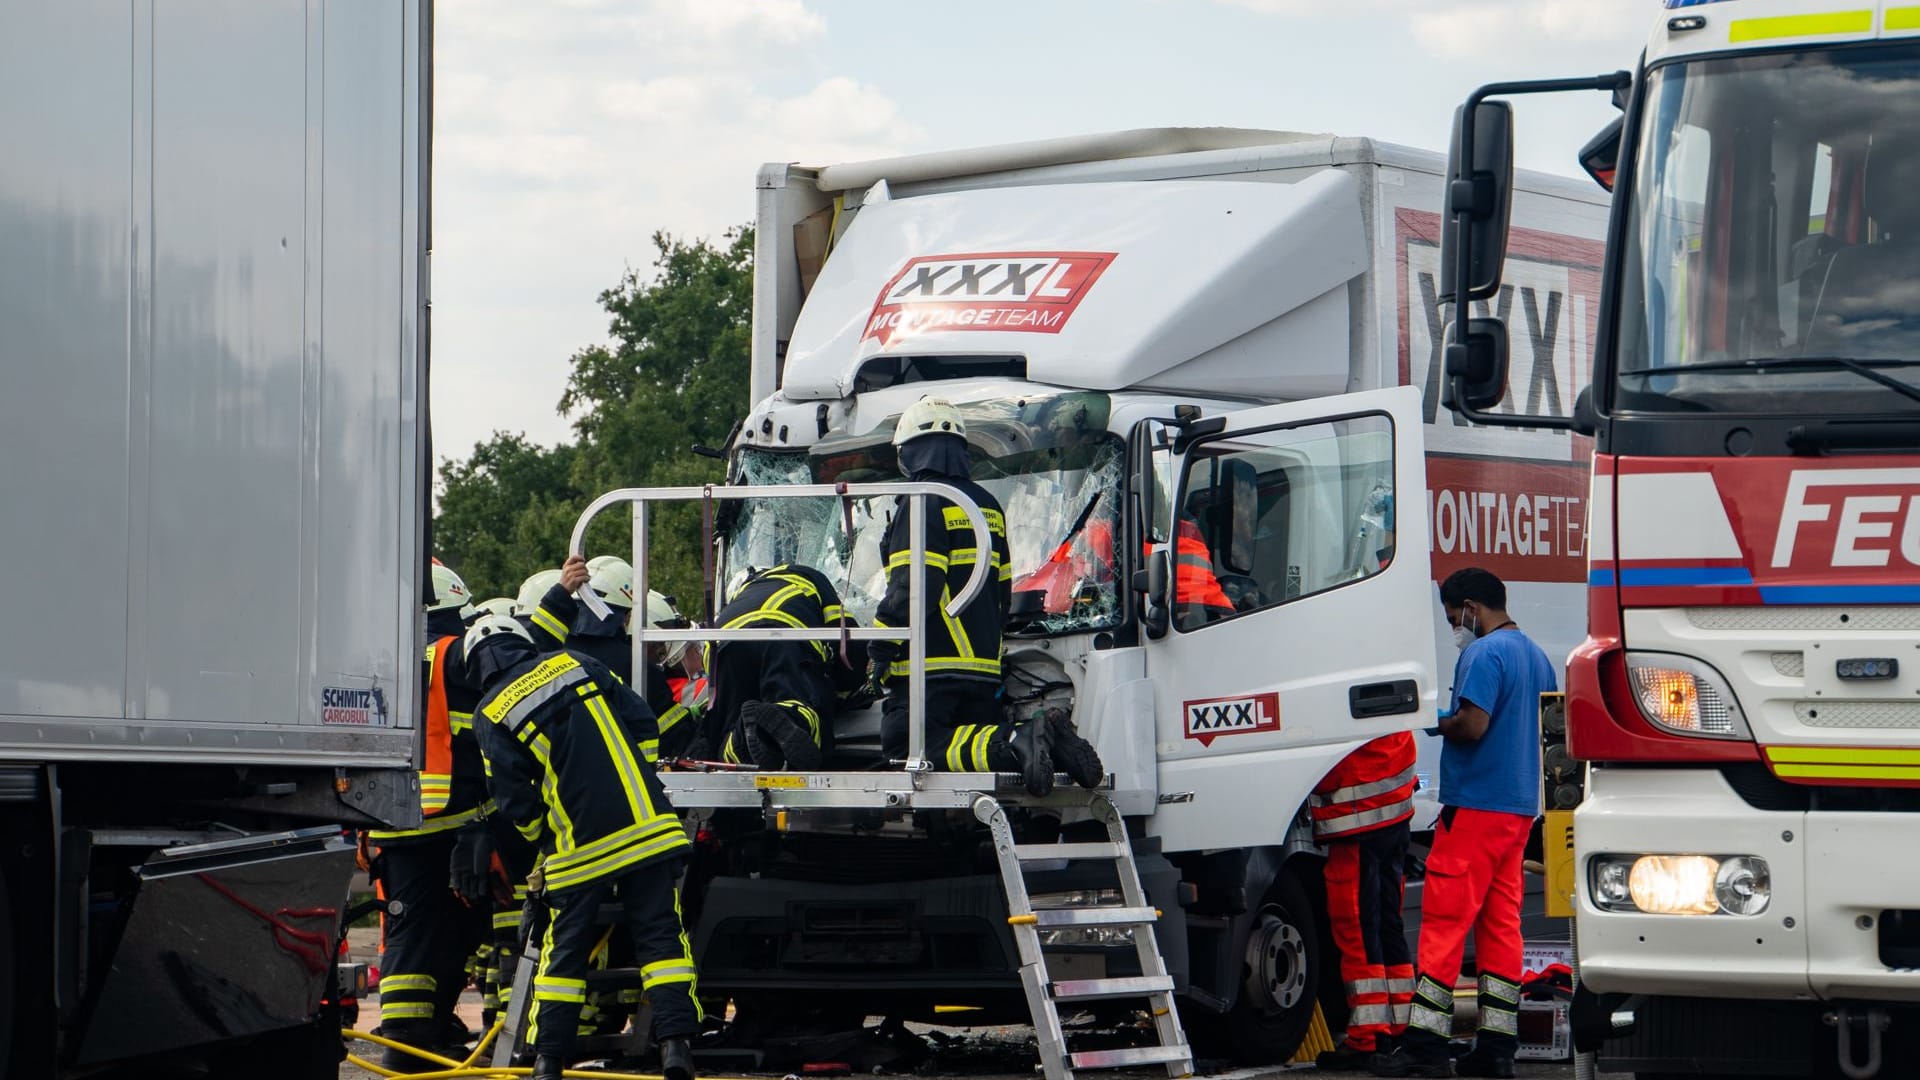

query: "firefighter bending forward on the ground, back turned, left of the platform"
left=467, top=617, right=701, bottom=1080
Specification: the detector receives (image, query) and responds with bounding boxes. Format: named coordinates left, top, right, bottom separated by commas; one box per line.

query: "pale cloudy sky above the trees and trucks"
left=432, top=0, right=1659, bottom=457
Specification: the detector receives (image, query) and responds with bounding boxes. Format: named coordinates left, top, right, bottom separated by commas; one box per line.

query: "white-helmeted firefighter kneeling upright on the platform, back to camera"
left=868, top=398, right=1106, bottom=796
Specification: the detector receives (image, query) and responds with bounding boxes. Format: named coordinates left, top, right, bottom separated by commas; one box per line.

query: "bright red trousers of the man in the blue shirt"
left=1407, top=807, right=1534, bottom=1055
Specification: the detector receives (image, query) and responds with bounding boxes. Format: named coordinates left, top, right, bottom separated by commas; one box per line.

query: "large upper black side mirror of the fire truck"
left=1440, top=102, right=1513, bottom=300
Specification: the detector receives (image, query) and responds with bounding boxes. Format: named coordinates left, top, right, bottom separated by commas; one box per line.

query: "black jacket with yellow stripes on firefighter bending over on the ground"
left=476, top=651, right=687, bottom=892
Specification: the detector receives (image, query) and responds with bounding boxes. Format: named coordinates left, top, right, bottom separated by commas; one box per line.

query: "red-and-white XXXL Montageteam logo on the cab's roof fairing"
left=862, top=252, right=1116, bottom=344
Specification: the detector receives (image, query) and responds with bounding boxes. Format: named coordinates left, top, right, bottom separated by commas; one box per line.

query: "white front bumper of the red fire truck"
left=1574, top=769, right=1920, bottom=1003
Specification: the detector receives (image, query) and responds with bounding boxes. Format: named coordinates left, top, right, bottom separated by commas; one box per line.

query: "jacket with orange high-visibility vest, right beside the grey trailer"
left=367, top=634, right=493, bottom=844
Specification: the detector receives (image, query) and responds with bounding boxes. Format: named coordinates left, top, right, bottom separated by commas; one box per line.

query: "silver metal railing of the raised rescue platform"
left=568, top=480, right=995, bottom=778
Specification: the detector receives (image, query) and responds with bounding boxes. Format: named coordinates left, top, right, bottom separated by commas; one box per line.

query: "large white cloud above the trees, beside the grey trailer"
left=434, top=0, right=922, bottom=455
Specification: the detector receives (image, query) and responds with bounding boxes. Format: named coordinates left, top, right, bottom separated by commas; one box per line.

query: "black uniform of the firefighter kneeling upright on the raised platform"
left=868, top=475, right=1018, bottom=773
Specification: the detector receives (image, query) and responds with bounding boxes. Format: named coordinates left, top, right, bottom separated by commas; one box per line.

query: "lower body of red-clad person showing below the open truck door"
left=1309, top=732, right=1417, bottom=1068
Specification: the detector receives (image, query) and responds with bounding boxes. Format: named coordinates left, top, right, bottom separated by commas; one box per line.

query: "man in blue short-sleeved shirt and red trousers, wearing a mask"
left=1371, top=567, right=1555, bottom=1076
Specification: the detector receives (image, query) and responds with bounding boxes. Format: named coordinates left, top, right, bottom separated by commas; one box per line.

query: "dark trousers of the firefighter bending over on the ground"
left=534, top=859, right=701, bottom=1059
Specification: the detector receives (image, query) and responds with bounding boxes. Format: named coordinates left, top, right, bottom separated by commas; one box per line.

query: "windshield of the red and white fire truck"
left=1615, top=42, right=1920, bottom=415
